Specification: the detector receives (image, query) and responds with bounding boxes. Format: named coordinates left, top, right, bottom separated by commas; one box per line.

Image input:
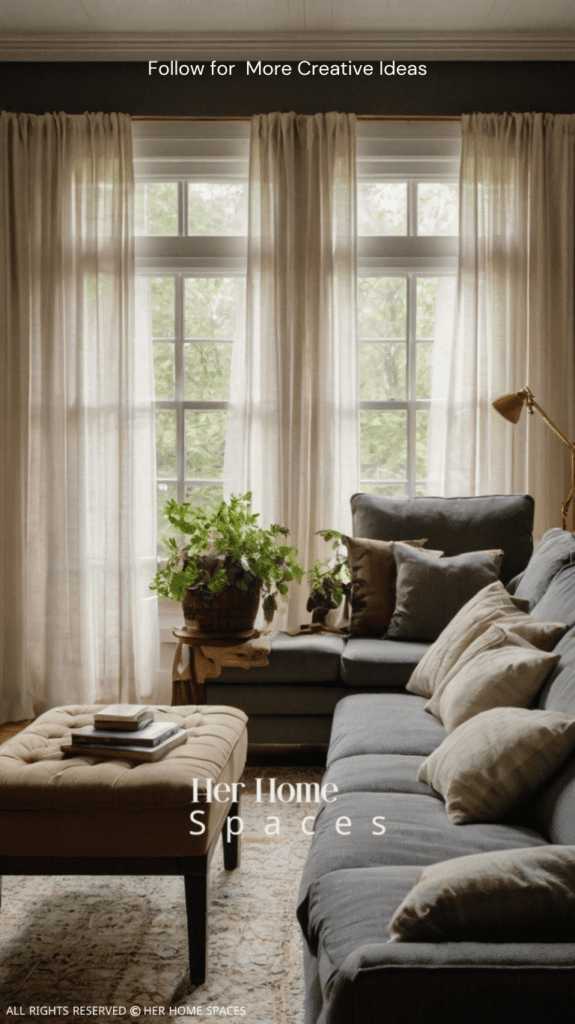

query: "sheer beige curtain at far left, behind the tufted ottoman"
left=0, top=114, right=159, bottom=720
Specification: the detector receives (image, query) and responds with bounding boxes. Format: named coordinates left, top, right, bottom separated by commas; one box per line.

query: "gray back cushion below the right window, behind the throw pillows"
left=351, top=494, right=534, bottom=583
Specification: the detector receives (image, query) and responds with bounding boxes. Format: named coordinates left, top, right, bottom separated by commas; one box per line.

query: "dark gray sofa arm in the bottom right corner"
left=318, top=942, right=575, bottom=1024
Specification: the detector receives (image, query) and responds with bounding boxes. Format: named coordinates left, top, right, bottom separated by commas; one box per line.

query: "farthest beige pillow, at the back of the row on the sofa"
left=406, top=580, right=567, bottom=697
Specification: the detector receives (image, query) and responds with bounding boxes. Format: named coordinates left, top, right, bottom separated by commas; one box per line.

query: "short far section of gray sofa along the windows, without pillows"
left=201, top=494, right=533, bottom=748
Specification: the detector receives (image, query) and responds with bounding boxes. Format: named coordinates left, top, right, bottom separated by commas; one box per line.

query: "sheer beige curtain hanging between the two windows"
left=224, top=114, right=359, bottom=628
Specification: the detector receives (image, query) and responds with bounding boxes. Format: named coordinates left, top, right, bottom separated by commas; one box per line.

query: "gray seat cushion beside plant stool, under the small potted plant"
left=213, top=632, right=346, bottom=686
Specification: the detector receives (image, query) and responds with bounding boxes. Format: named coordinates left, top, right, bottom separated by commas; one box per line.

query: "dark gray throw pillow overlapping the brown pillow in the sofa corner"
left=387, top=544, right=503, bottom=642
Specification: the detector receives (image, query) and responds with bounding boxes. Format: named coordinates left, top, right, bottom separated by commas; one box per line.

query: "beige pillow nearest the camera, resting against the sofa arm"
left=390, top=846, right=575, bottom=942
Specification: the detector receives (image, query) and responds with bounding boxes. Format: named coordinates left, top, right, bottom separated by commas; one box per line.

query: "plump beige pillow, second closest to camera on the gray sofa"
left=417, top=708, right=575, bottom=825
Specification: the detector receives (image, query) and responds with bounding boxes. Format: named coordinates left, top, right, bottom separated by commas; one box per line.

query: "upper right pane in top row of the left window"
left=187, top=181, right=248, bottom=234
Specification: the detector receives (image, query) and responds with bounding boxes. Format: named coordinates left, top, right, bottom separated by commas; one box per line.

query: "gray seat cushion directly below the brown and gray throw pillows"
left=341, top=637, right=430, bottom=689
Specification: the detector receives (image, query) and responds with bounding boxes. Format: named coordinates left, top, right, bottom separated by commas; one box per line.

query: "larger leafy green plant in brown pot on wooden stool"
left=150, top=493, right=303, bottom=634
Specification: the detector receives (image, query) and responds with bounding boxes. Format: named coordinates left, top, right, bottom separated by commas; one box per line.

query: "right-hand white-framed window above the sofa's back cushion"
left=357, top=122, right=460, bottom=498
